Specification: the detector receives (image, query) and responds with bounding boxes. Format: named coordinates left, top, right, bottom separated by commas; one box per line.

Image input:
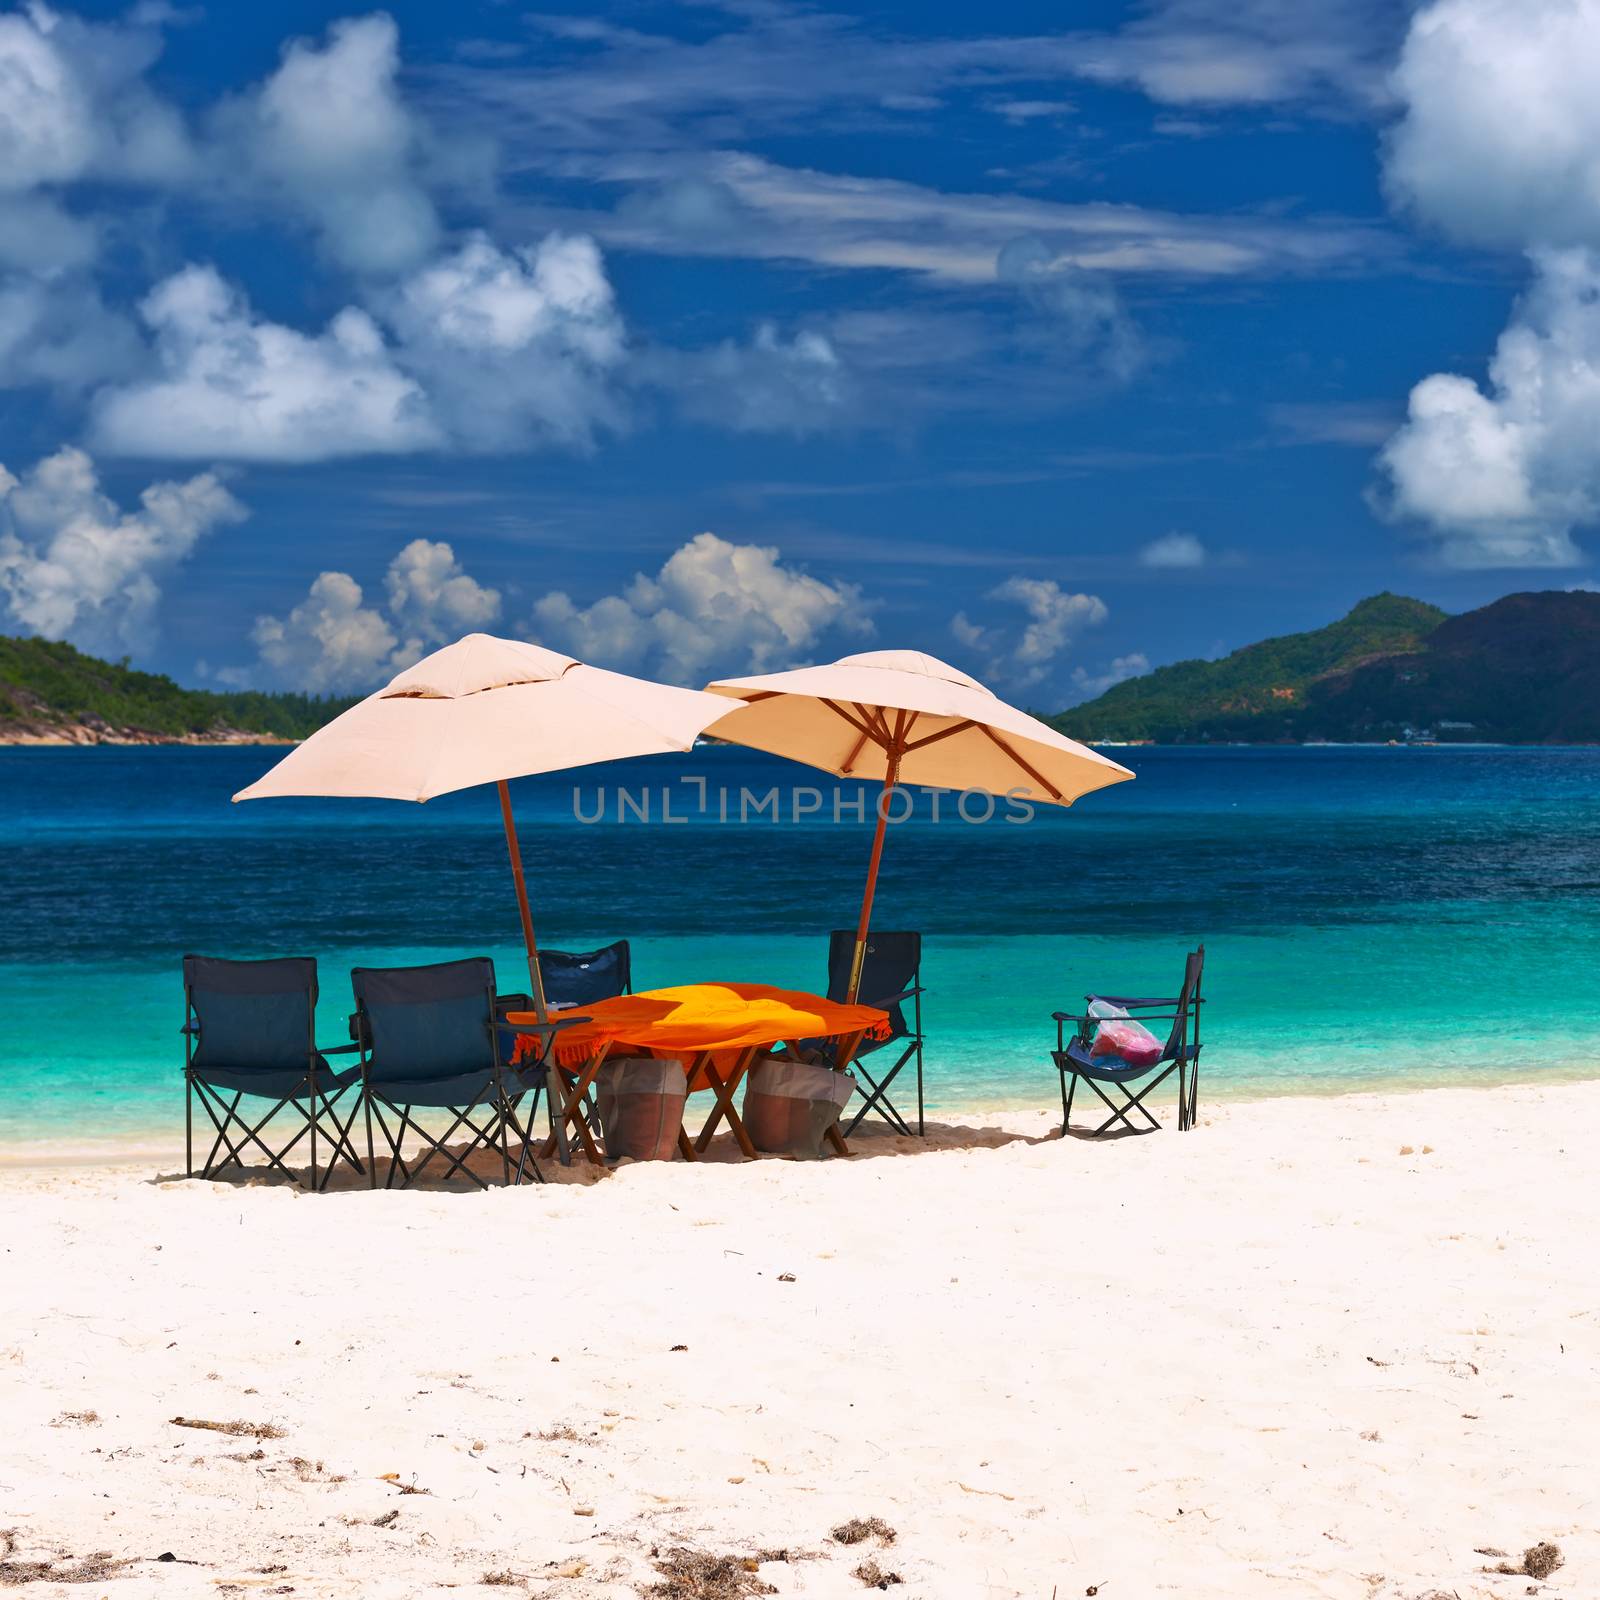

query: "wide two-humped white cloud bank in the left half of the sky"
left=94, top=235, right=627, bottom=461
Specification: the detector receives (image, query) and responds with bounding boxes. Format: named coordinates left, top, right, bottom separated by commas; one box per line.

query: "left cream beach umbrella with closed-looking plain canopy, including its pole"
left=234, top=634, right=728, bottom=1021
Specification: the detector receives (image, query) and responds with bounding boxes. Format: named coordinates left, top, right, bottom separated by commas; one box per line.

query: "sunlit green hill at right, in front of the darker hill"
left=1050, top=594, right=1446, bottom=744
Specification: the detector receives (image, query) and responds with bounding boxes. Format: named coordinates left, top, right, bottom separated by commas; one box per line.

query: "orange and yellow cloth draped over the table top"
left=506, top=984, right=890, bottom=1093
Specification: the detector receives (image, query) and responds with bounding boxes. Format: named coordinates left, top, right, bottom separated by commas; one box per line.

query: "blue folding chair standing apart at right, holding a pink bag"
left=1051, top=944, right=1205, bottom=1138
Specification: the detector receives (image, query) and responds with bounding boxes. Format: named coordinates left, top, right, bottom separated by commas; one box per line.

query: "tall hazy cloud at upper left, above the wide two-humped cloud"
left=216, top=11, right=440, bottom=274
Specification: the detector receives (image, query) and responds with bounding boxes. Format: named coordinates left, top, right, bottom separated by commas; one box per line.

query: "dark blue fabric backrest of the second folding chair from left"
left=350, top=955, right=498, bottom=1083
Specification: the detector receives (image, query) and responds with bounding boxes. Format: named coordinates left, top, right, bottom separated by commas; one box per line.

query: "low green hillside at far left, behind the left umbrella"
left=0, top=635, right=350, bottom=741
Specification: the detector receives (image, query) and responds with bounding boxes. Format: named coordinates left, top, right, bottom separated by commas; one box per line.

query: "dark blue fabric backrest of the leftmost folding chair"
left=184, top=955, right=317, bottom=1072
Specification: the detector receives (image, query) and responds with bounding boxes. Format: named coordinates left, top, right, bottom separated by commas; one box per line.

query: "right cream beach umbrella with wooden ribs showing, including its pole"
left=706, top=650, right=1133, bottom=1002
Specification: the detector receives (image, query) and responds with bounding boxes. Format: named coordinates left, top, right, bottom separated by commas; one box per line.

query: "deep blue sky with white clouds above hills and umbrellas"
left=0, top=0, right=1600, bottom=707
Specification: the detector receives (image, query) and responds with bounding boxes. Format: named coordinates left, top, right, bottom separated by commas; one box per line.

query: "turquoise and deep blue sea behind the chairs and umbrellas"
left=0, top=746, right=1600, bottom=1157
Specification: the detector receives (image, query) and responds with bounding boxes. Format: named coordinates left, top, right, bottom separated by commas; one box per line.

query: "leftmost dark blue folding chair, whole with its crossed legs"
left=182, top=955, right=362, bottom=1190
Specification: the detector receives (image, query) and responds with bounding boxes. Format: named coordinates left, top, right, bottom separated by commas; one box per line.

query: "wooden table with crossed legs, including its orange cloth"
left=506, top=984, right=890, bottom=1165
